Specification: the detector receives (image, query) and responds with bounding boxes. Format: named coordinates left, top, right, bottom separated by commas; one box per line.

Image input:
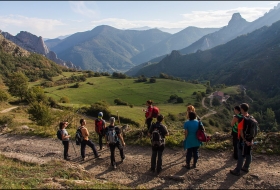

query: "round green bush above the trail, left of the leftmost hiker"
left=28, top=102, right=53, bottom=126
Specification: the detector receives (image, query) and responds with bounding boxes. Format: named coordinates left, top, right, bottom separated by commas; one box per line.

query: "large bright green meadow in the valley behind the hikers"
left=44, top=74, right=205, bottom=106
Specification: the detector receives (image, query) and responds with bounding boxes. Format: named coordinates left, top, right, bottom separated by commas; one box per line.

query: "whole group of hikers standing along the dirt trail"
left=60, top=100, right=256, bottom=176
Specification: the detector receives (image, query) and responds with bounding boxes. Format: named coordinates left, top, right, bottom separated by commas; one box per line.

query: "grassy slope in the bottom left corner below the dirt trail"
left=0, top=155, right=128, bottom=189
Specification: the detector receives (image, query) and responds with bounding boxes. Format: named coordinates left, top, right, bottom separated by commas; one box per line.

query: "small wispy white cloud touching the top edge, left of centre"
left=69, top=1, right=98, bottom=18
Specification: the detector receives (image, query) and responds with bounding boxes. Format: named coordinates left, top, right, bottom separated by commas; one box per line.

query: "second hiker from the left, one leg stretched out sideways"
left=80, top=119, right=99, bottom=161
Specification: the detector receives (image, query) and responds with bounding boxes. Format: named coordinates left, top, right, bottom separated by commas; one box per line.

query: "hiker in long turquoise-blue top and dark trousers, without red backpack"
left=184, top=112, right=201, bottom=169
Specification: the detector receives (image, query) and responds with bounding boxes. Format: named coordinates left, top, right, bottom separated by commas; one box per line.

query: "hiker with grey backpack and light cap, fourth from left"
left=105, top=117, right=125, bottom=169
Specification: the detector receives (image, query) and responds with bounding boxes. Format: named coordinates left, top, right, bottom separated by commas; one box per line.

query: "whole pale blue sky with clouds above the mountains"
left=0, top=1, right=280, bottom=39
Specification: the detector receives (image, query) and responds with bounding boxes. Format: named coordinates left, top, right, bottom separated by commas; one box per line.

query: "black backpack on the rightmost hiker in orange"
left=243, top=115, right=259, bottom=140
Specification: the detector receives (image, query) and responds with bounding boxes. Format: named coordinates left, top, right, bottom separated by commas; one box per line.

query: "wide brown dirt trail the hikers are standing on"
left=0, top=134, right=280, bottom=189
